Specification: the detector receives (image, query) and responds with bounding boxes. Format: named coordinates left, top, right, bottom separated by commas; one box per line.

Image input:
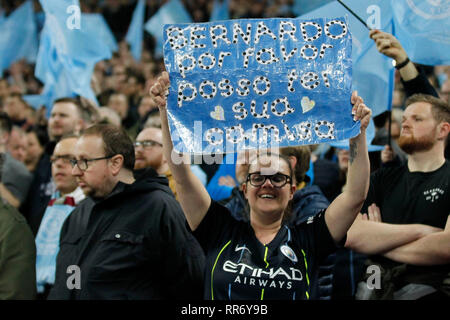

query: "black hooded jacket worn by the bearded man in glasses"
left=49, top=169, right=204, bottom=300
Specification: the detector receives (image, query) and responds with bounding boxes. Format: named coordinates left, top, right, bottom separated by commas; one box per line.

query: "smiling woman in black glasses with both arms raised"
left=150, top=72, right=371, bottom=300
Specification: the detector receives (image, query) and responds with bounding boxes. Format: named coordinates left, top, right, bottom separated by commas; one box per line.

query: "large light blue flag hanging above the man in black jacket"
left=35, top=0, right=111, bottom=112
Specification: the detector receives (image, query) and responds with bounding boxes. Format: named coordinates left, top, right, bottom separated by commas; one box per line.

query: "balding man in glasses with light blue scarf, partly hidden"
left=36, top=135, right=85, bottom=299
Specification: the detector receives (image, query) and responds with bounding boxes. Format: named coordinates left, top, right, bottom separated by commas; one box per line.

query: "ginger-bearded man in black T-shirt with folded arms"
left=346, top=94, right=450, bottom=300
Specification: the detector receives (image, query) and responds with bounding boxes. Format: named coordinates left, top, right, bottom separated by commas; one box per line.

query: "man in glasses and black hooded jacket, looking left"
left=49, top=124, right=204, bottom=300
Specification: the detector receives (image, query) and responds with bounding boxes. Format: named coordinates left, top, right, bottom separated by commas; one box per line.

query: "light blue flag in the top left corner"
left=0, top=1, right=38, bottom=75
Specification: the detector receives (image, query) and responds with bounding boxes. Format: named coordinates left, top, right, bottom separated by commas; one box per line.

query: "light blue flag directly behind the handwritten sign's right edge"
left=299, top=0, right=395, bottom=116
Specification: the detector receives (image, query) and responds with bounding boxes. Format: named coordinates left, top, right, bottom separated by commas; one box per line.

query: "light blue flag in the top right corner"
left=391, top=0, right=450, bottom=65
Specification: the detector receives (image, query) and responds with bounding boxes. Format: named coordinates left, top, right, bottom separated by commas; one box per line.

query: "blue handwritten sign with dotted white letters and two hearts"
left=164, top=18, right=359, bottom=153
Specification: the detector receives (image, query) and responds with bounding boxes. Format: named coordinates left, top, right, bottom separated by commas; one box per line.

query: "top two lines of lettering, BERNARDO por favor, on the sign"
left=166, top=19, right=348, bottom=78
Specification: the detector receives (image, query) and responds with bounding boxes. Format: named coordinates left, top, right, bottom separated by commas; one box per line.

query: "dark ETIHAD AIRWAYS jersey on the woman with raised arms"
left=194, top=202, right=345, bottom=300
